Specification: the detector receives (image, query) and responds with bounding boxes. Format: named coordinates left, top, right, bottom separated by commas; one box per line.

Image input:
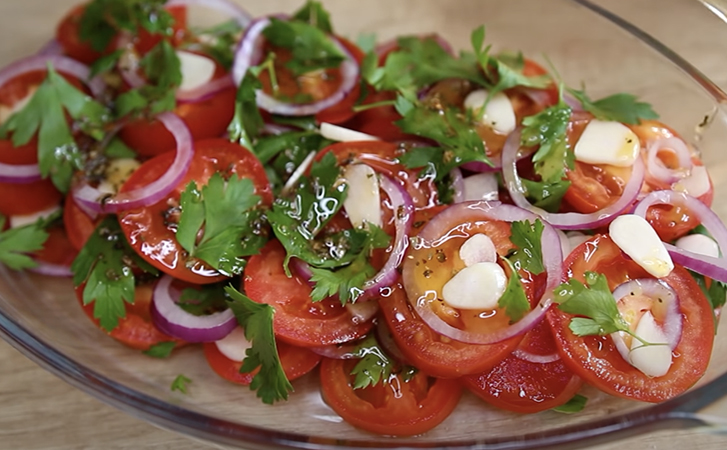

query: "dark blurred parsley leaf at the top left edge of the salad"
left=78, top=0, right=174, bottom=52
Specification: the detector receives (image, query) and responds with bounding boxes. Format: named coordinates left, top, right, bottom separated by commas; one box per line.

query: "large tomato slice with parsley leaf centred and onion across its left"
left=119, top=139, right=273, bottom=284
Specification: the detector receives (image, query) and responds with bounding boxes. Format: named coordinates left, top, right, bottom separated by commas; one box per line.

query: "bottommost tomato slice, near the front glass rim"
left=320, top=358, right=462, bottom=436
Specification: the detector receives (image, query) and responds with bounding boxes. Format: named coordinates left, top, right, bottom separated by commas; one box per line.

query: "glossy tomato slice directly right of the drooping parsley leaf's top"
left=243, top=240, right=375, bottom=347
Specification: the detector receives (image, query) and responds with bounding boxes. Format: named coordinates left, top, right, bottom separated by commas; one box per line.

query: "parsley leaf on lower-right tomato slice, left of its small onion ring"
left=555, top=272, right=632, bottom=336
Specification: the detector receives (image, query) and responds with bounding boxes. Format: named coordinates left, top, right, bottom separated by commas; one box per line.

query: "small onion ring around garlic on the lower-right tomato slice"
left=613, top=278, right=683, bottom=354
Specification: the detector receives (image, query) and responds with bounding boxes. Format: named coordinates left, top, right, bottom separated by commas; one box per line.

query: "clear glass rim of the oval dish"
left=0, top=0, right=727, bottom=450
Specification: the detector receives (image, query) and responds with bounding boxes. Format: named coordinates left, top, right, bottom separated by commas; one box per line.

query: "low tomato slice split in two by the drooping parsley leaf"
left=203, top=341, right=321, bottom=386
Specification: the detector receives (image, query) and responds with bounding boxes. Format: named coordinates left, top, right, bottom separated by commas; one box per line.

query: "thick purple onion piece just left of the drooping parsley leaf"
left=151, top=275, right=237, bottom=342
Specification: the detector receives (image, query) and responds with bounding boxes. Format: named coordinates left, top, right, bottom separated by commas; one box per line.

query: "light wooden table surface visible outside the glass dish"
left=7, top=0, right=727, bottom=450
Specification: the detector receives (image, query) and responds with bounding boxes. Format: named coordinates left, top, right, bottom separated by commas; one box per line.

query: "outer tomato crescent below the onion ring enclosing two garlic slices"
left=379, top=286, right=521, bottom=378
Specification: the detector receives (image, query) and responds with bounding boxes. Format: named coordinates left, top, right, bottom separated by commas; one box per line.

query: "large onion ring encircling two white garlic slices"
left=402, top=201, right=563, bottom=344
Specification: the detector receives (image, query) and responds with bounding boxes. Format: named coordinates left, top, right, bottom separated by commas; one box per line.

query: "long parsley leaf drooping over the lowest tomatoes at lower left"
left=225, top=286, right=293, bottom=404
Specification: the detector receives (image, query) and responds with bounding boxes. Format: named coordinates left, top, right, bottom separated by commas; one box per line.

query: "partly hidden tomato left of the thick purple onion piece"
left=76, top=283, right=185, bottom=350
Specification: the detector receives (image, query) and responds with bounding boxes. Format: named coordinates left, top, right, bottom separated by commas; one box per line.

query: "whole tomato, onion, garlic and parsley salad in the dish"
left=0, top=0, right=727, bottom=436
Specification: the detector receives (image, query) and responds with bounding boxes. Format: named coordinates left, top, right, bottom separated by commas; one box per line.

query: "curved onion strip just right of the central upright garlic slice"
left=358, top=175, right=414, bottom=302
